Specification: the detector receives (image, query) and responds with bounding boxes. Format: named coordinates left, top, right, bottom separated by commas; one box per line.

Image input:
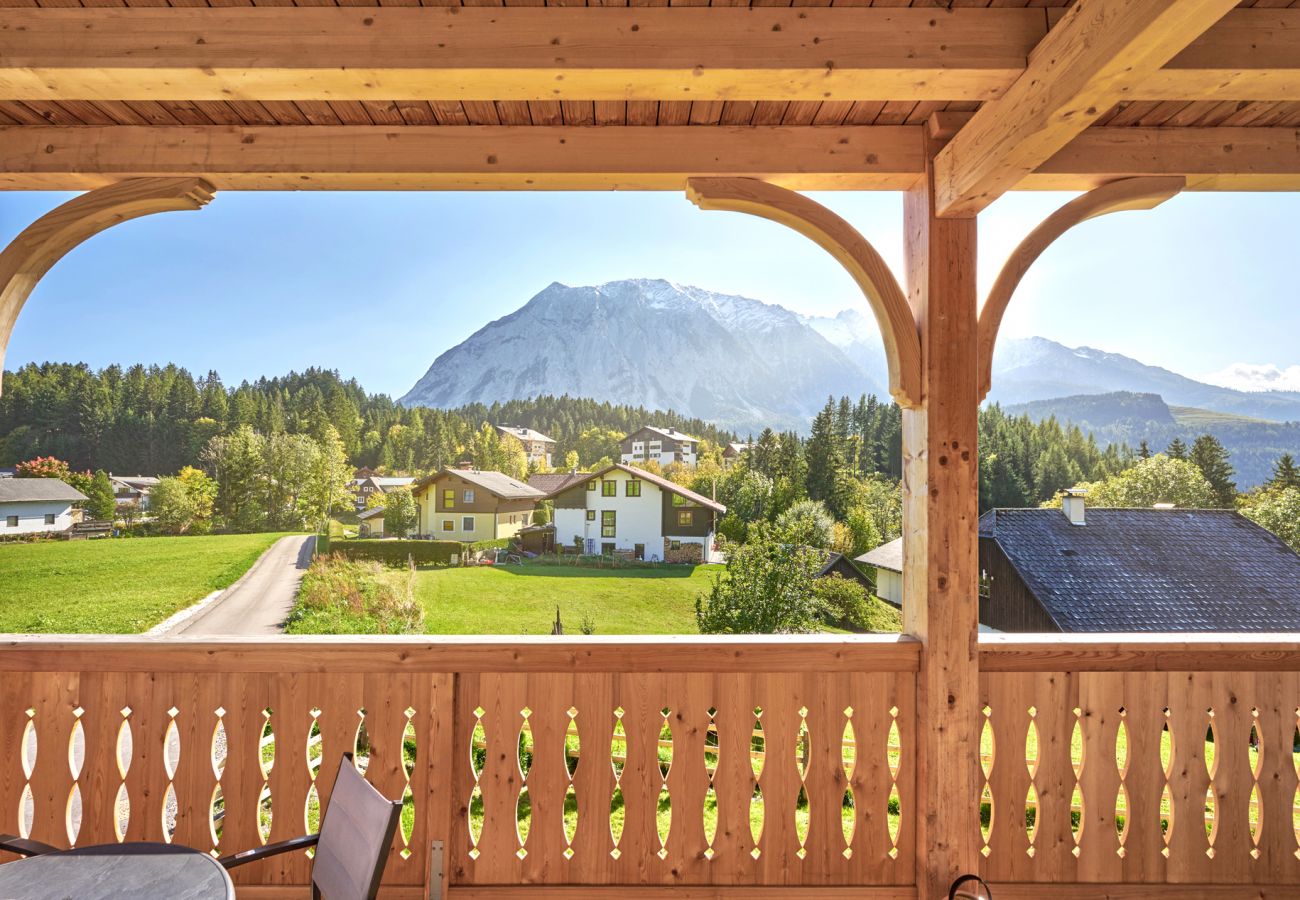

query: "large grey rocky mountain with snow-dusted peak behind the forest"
left=400, top=278, right=884, bottom=432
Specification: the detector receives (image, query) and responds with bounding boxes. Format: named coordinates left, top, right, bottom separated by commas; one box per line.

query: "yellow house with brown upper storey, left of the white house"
left=412, top=468, right=546, bottom=542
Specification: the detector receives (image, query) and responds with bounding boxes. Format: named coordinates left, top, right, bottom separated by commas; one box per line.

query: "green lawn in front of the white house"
left=415, top=563, right=723, bottom=635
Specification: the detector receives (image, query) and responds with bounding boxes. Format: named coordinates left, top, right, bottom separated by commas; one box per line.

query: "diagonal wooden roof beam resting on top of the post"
left=935, top=0, right=1236, bottom=216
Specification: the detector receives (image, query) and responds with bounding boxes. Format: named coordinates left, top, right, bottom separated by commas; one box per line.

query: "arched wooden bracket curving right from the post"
left=979, top=176, right=1187, bottom=401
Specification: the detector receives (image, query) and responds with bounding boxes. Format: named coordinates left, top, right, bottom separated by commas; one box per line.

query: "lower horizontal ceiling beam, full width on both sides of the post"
left=0, top=120, right=1300, bottom=191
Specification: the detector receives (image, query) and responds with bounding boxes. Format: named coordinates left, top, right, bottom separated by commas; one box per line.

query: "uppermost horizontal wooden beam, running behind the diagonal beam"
left=0, top=7, right=1300, bottom=101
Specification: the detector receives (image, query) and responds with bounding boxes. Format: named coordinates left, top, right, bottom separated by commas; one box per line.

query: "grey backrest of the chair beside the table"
left=312, top=753, right=402, bottom=900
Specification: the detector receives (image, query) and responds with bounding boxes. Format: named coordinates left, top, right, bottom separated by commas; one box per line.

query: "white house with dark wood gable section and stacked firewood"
left=550, top=463, right=727, bottom=563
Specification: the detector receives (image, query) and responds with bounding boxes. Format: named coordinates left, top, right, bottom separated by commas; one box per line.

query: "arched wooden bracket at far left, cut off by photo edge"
left=0, top=178, right=216, bottom=392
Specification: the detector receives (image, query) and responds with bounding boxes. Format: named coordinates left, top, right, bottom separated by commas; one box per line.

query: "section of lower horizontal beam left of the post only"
left=0, top=125, right=922, bottom=191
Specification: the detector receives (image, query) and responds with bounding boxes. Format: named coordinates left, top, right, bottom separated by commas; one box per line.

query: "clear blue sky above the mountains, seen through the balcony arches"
left=0, top=192, right=1300, bottom=395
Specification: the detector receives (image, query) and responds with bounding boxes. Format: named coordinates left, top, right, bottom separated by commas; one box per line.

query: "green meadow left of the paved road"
left=0, top=535, right=283, bottom=635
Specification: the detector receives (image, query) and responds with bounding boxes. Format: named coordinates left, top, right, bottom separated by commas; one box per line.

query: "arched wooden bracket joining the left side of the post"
left=686, top=178, right=922, bottom=408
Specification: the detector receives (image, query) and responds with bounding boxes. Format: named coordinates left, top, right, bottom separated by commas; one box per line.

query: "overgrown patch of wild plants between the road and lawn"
left=285, top=554, right=424, bottom=635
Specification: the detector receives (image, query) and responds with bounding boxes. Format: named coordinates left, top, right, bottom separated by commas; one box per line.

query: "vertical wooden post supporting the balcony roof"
left=902, top=130, right=980, bottom=900
